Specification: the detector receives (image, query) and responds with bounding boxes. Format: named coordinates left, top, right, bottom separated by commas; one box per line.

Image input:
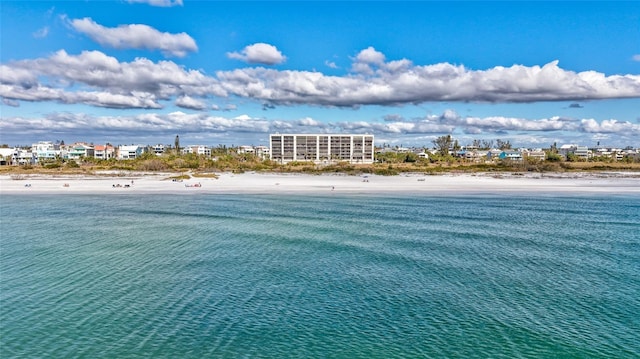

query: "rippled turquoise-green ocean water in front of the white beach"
left=0, top=194, right=640, bottom=358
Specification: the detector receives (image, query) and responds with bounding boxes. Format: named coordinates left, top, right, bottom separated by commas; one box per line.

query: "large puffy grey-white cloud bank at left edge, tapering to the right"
left=0, top=50, right=220, bottom=108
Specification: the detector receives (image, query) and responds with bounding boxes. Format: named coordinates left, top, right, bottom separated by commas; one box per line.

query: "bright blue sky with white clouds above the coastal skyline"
left=0, top=0, right=640, bottom=148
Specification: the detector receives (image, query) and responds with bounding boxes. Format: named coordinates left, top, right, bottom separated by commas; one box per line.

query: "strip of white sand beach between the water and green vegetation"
left=0, top=172, right=640, bottom=194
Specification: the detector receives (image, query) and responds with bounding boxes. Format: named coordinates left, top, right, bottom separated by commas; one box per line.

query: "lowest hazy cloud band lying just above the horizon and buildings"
left=0, top=110, right=640, bottom=145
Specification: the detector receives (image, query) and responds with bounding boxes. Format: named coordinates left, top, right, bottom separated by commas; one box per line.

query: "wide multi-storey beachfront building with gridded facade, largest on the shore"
left=269, top=133, right=375, bottom=163
